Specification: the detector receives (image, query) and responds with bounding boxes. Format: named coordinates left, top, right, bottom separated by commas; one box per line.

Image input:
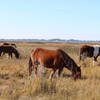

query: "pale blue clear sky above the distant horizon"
left=0, top=0, right=100, bottom=40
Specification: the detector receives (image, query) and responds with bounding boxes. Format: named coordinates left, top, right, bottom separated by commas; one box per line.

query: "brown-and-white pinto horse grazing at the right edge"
left=80, top=45, right=100, bottom=61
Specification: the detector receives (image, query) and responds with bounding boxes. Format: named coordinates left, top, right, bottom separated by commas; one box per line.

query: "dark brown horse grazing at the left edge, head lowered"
left=0, top=45, right=20, bottom=59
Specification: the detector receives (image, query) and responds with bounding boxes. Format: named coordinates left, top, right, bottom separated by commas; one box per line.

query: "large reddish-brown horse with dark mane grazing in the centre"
left=29, top=48, right=81, bottom=79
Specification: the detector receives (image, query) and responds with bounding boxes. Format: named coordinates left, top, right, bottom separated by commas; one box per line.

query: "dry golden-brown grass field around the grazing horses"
left=0, top=42, right=100, bottom=100
